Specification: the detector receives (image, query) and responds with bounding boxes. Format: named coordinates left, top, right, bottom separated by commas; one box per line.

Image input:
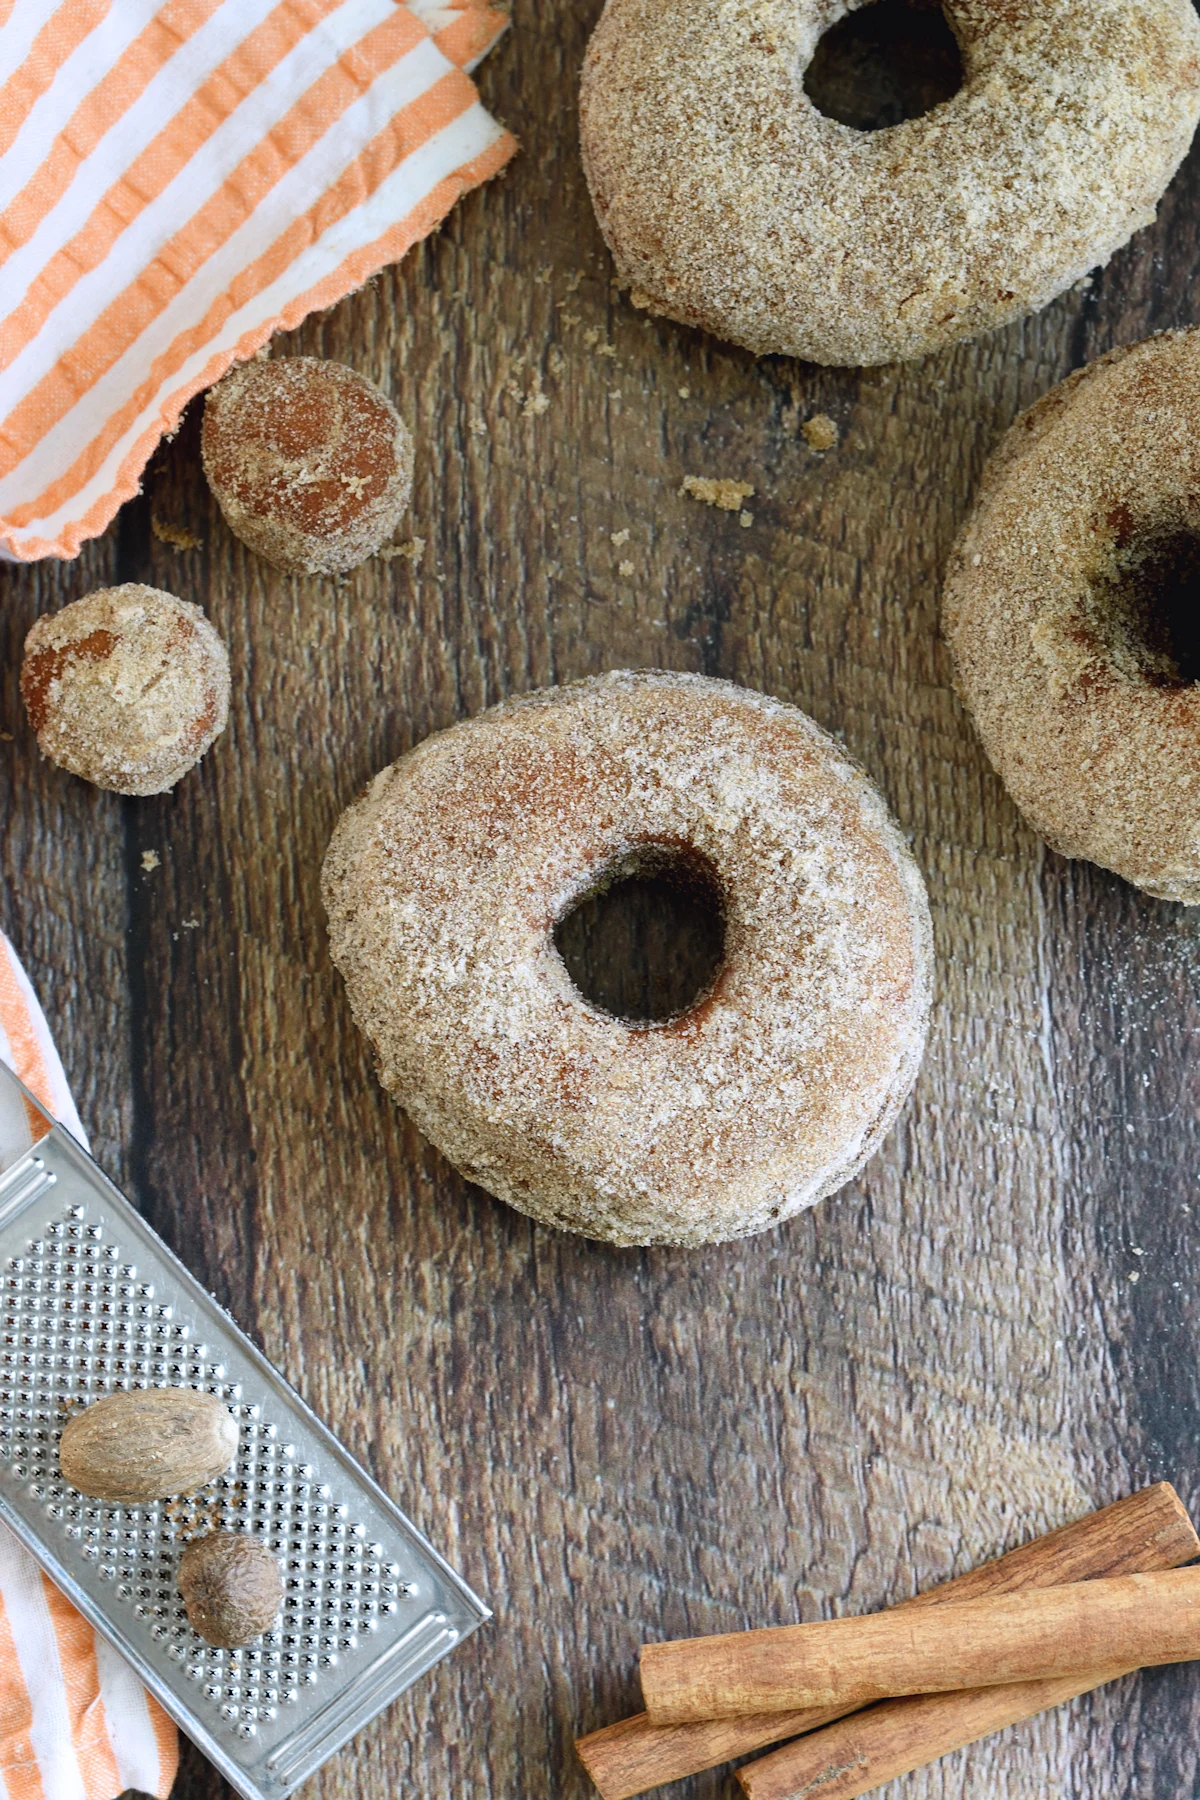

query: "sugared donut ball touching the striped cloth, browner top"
left=200, top=356, right=412, bottom=574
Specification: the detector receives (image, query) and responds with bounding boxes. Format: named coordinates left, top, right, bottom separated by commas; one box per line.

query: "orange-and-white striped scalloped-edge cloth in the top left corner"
left=0, top=0, right=516, bottom=562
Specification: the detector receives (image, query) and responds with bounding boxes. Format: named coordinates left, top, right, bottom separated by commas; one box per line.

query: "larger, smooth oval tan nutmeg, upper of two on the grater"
left=58, top=1388, right=237, bottom=1507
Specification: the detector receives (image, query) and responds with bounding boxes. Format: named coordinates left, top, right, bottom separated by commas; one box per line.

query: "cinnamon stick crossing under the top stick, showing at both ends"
left=576, top=1481, right=1200, bottom=1800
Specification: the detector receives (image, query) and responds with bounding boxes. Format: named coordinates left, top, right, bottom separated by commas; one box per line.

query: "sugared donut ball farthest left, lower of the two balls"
left=22, top=581, right=228, bottom=794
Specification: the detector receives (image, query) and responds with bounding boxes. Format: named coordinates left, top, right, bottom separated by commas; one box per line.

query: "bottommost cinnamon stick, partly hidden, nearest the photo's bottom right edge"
left=738, top=1669, right=1130, bottom=1800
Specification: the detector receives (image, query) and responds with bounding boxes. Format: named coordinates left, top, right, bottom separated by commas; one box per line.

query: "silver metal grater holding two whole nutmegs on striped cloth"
left=0, top=1064, right=491, bottom=1800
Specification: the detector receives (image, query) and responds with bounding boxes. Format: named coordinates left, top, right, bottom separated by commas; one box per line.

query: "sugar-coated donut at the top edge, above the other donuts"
left=581, top=0, right=1200, bottom=364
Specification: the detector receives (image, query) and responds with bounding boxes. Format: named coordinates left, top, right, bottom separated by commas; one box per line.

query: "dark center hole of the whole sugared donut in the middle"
left=554, top=844, right=725, bottom=1026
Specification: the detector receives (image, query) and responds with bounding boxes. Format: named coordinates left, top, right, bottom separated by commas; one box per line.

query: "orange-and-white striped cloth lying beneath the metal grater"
left=0, top=932, right=178, bottom=1800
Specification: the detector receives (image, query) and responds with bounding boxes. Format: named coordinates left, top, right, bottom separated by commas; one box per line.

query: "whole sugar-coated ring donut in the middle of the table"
left=324, top=673, right=932, bottom=1244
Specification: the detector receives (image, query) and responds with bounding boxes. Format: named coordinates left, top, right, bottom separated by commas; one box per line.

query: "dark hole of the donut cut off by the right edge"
left=1092, top=531, right=1200, bottom=688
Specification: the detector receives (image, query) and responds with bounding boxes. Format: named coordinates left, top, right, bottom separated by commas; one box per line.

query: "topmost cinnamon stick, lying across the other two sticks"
left=642, top=1570, right=1200, bottom=1724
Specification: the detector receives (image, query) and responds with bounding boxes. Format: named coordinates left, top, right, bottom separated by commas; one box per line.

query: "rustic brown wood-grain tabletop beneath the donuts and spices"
left=0, top=0, right=1200, bottom=1800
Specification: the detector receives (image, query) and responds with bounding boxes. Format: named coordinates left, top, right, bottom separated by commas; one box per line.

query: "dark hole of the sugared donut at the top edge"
left=804, top=0, right=964, bottom=131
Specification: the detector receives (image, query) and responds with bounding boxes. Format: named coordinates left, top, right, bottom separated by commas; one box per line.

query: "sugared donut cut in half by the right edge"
left=945, top=331, right=1200, bottom=905
